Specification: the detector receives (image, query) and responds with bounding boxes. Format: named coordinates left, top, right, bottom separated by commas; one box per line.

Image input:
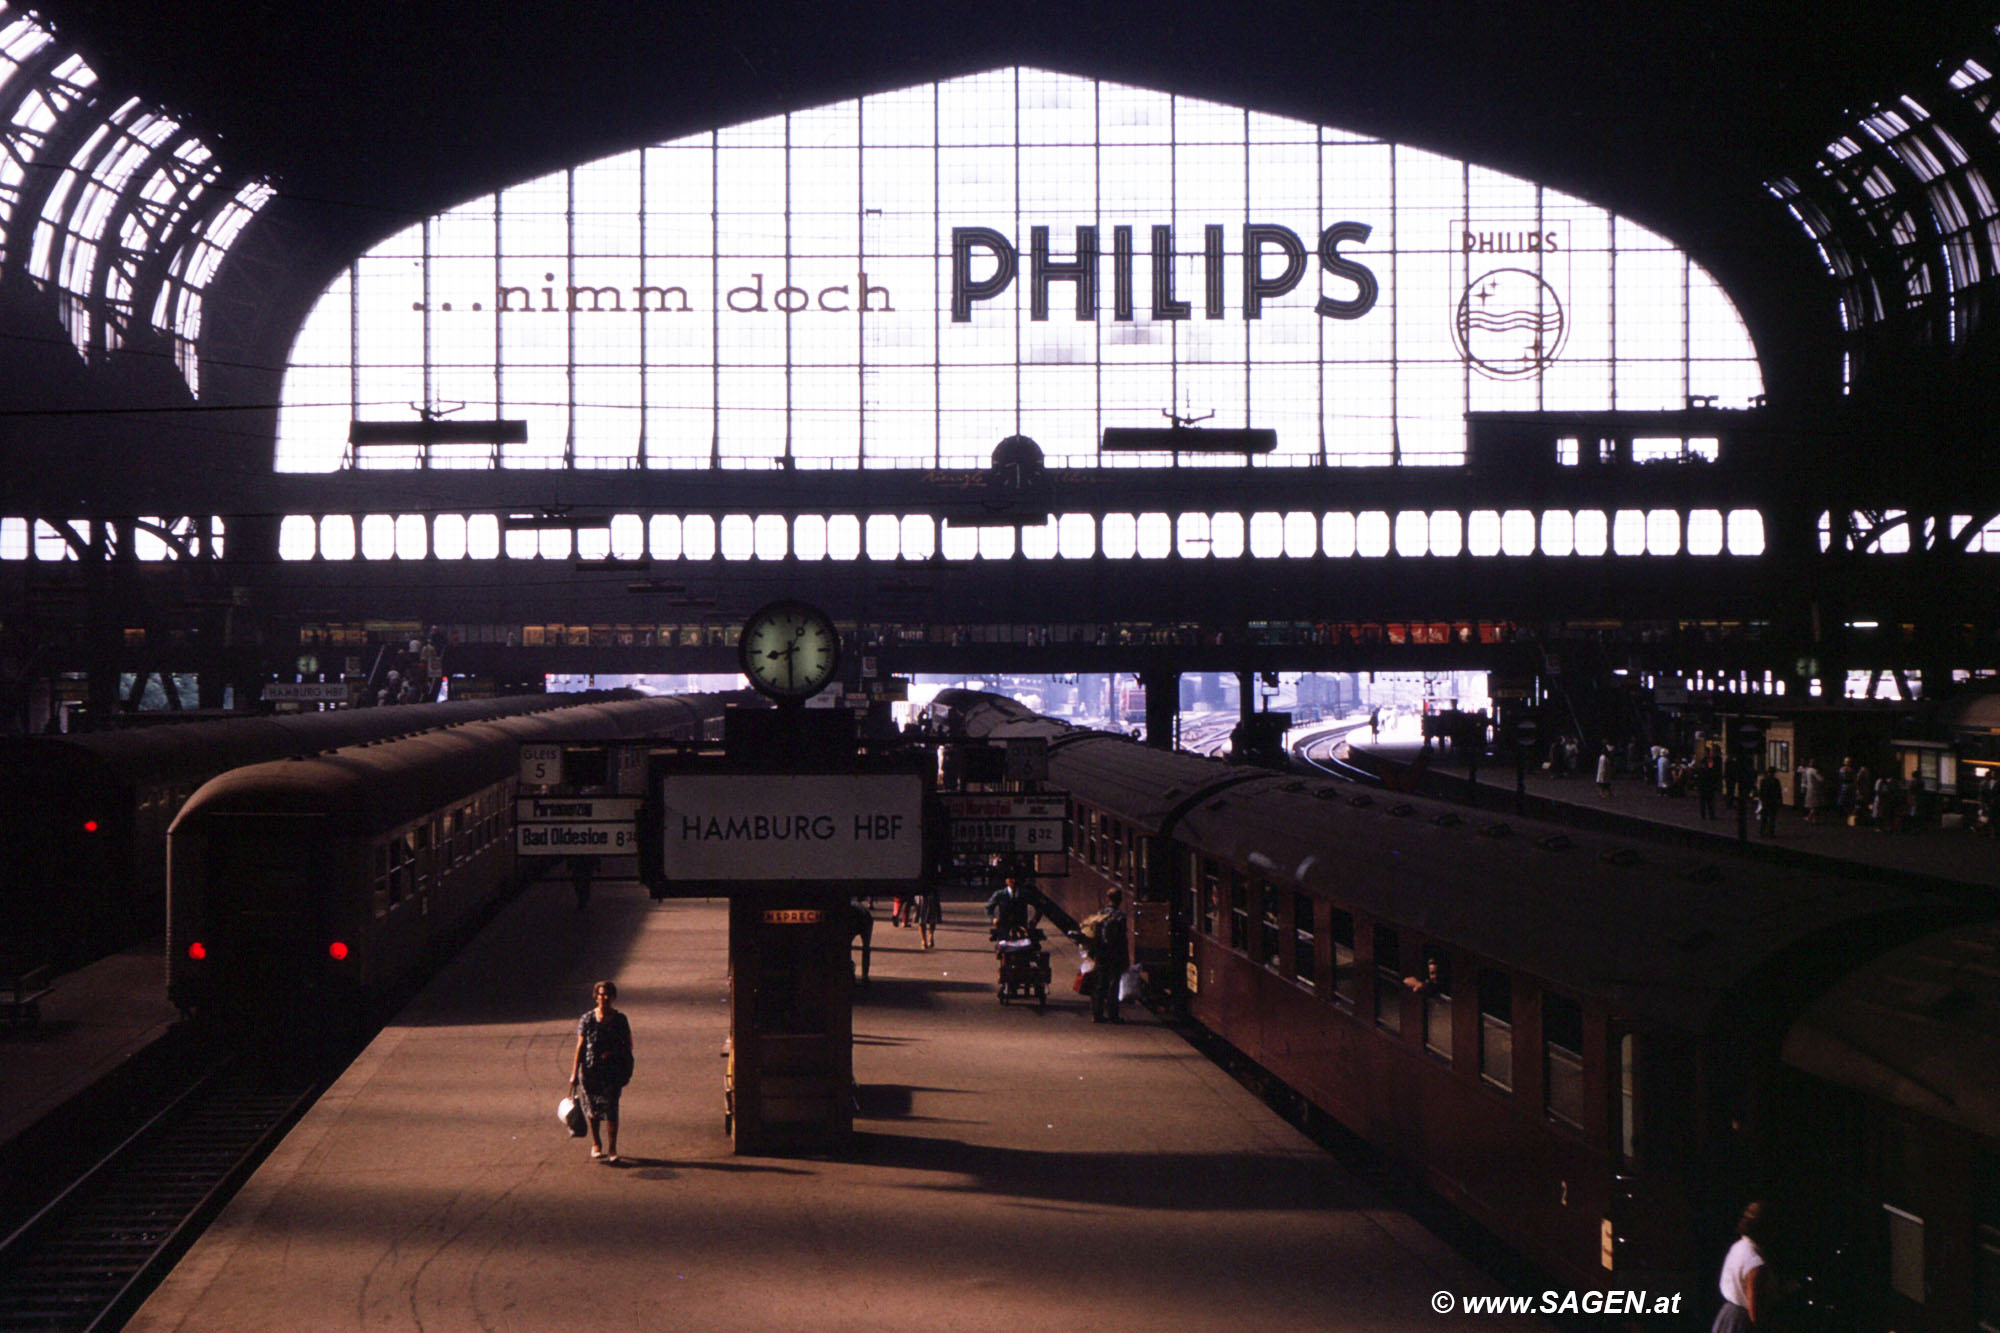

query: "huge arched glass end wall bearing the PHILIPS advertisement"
left=278, top=68, right=1762, bottom=470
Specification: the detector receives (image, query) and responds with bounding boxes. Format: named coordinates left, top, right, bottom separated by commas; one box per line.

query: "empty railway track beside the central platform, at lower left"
left=0, top=1053, right=324, bottom=1333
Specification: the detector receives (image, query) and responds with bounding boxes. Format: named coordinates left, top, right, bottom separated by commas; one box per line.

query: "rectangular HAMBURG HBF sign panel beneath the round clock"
left=660, top=773, right=924, bottom=881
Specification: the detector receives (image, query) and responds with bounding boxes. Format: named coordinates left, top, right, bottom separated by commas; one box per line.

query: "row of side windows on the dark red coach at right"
left=1184, top=852, right=1608, bottom=1157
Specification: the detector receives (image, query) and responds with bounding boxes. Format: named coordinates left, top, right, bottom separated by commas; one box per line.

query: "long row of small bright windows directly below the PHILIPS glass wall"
left=258, top=508, right=1764, bottom=560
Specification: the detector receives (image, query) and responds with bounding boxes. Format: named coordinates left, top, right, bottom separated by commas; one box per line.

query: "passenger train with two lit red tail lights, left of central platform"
left=166, top=695, right=728, bottom=1013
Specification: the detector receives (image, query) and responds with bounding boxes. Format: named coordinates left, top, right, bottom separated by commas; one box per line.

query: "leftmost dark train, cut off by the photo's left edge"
left=0, top=695, right=624, bottom=965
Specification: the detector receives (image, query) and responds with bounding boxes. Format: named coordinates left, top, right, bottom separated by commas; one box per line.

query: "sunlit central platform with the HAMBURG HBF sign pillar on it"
left=128, top=883, right=1544, bottom=1333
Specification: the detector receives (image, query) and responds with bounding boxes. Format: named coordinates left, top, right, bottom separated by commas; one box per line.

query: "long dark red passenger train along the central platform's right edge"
left=932, top=693, right=2000, bottom=1331
